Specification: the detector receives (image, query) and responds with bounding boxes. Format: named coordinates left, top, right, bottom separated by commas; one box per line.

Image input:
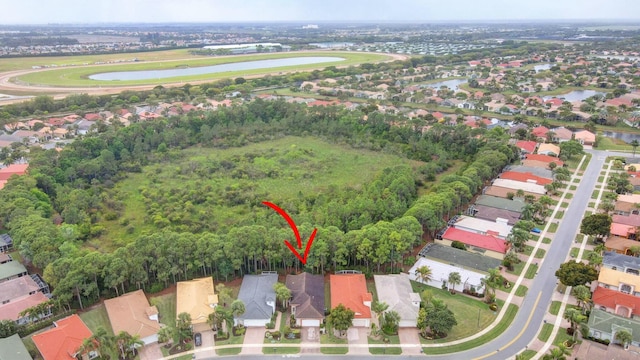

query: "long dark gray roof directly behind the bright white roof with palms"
left=420, top=243, right=500, bottom=272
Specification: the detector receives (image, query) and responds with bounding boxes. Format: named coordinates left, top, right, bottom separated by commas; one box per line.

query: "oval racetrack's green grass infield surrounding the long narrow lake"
left=16, top=51, right=391, bottom=87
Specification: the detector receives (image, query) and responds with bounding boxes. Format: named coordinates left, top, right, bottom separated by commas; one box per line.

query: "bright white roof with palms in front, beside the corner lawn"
left=409, top=257, right=486, bottom=293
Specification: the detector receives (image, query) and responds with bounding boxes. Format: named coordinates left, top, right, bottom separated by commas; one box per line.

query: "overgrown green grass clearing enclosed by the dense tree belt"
left=97, top=137, right=421, bottom=250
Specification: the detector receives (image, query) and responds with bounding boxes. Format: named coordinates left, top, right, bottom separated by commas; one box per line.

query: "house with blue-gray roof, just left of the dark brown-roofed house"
left=235, top=273, right=278, bottom=326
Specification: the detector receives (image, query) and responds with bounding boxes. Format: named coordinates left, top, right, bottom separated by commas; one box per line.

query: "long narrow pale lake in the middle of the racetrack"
left=89, top=56, right=345, bottom=81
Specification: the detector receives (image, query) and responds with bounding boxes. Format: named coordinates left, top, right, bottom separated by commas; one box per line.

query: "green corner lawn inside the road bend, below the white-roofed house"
left=411, top=281, right=502, bottom=344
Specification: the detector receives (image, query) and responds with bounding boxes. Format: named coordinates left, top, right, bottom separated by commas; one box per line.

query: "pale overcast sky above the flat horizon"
left=0, top=0, right=640, bottom=25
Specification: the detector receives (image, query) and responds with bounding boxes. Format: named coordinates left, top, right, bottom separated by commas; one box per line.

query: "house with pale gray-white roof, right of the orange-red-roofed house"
left=373, top=274, right=424, bottom=328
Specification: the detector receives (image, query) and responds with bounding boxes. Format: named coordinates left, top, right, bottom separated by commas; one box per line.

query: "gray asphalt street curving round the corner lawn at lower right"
left=200, top=150, right=615, bottom=360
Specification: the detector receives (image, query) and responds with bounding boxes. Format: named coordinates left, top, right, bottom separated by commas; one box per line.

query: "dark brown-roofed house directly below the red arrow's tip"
left=286, top=272, right=325, bottom=327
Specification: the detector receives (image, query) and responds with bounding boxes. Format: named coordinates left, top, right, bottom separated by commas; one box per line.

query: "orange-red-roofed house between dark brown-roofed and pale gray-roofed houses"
left=329, top=274, right=373, bottom=328
